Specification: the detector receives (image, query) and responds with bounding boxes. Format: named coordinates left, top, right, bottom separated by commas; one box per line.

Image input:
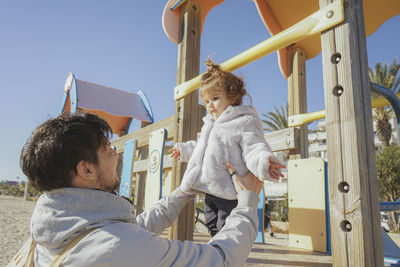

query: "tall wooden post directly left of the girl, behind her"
left=168, top=0, right=201, bottom=241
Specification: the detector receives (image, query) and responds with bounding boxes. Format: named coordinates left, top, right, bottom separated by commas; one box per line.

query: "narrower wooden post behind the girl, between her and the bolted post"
left=288, top=48, right=308, bottom=159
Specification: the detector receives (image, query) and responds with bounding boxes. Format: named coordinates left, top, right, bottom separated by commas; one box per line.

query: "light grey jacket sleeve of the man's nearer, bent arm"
left=112, top=188, right=258, bottom=267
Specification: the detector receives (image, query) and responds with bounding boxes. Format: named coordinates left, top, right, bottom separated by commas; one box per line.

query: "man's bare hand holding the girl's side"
left=226, top=162, right=264, bottom=196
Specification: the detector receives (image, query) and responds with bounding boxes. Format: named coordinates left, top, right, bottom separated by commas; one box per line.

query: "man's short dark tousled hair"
left=20, top=112, right=111, bottom=191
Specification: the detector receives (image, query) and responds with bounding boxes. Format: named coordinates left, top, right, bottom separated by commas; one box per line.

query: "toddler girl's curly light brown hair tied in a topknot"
left=200, top=59, right=247, bottom=106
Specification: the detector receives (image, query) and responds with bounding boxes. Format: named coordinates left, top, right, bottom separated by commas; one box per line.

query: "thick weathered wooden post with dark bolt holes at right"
left=319, top=0, right=383, bottom=266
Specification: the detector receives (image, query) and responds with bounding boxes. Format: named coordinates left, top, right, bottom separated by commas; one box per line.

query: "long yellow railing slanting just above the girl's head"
left=174, top=1, right=344, bottom=100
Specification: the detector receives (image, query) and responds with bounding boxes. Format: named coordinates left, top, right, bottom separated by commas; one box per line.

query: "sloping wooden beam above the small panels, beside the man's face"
left=111, top=116, right=174, bottom=153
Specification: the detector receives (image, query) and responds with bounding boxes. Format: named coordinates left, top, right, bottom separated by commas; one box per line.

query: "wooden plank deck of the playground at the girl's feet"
left=162, top=232, right=332, bottom=267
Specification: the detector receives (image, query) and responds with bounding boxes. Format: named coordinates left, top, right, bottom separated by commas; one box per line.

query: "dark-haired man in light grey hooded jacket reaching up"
left=20, top=113, right=262, bottom=266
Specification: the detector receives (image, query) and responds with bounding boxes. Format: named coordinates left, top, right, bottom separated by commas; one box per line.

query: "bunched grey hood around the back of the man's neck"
left=30, top=187, right=136, bottom=248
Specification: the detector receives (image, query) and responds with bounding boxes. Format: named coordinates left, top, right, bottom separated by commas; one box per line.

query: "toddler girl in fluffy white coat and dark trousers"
left=170, top=60, right=285, bottom=236
